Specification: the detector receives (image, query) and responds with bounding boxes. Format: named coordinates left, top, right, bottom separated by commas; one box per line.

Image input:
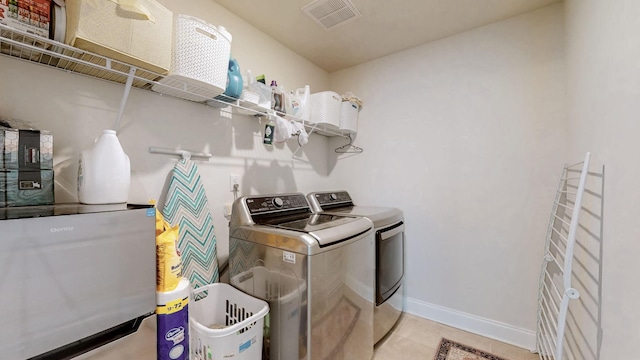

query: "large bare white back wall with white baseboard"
left=329, top=5, right=566, bottom=348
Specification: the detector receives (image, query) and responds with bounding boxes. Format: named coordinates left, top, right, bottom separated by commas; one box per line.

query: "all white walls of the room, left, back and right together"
left=13, top=0, right=640, bottom=359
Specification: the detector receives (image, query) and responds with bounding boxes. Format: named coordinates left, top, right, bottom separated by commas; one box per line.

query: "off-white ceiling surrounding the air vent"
left=214, top=0, right=561, bottom=72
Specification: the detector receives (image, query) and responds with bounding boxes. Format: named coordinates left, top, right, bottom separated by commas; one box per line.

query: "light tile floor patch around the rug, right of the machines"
left=373, top=313, right=538, bottom=360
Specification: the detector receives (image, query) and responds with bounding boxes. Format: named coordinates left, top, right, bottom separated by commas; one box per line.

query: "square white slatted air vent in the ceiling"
left=302, top=0, right=362, bottom=30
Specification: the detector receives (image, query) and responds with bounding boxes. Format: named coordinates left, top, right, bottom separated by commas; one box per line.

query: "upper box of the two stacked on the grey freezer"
left=0, top=128, right=53, bottom=170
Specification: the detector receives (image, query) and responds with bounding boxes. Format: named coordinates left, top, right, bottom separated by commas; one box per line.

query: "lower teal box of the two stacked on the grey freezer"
left=0, top=170, right=54, bottom=207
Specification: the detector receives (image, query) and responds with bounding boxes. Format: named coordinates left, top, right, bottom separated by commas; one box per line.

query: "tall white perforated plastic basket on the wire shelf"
left=152, top=15, right=231, bottom=102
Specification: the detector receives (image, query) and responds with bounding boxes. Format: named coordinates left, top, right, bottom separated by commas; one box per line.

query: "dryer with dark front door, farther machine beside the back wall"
left=307, top=191, right=404, bottom=344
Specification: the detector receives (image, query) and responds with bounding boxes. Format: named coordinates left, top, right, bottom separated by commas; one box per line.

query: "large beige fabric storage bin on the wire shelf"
left=65, top=0, right=173, bottom=74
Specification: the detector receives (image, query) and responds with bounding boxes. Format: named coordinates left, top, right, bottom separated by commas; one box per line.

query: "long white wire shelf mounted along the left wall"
left=0, top=24, right=349, bottom=138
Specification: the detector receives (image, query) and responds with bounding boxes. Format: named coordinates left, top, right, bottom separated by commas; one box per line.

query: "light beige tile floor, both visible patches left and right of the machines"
left=76, top=313, right=538, bottom=360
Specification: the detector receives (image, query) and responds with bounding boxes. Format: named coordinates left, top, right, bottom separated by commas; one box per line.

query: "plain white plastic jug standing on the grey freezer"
left=78, top=130, right=131, bottom=204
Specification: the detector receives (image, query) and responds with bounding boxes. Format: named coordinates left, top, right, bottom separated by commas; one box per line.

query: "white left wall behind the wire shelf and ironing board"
left=0, top=0, right=336, bottom=266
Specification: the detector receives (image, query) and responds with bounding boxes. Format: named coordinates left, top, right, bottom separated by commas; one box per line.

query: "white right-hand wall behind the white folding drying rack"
left=565, top=0, right=640, bottom=360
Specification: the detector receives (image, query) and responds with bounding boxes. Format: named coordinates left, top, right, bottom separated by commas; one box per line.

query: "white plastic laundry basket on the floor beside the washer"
left=189, top=283, right=269, bottom=360
